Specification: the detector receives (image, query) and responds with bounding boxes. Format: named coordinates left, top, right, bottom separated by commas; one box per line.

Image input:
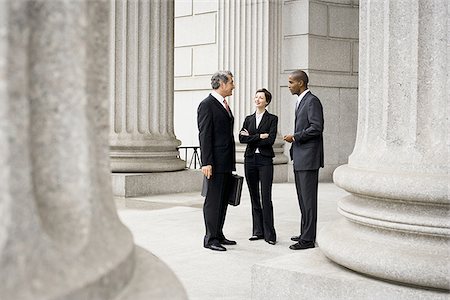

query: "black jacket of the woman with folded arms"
left=239, top=111, right=278, bottom=157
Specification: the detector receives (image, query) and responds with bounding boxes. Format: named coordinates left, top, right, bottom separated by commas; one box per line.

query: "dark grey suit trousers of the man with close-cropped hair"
left=294, top=170, right=319, bottom=243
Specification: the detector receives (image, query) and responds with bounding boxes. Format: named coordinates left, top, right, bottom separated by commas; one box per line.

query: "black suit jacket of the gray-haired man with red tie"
left=197, top=94, right=236, bottom=174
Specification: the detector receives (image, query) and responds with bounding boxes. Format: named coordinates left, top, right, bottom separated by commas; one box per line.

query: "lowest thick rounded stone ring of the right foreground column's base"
left=318, top=218, right=450, bottom=291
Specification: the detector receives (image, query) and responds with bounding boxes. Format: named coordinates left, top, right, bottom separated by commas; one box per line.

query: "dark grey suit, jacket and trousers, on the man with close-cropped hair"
left=291, top=92, right=324, bottom=244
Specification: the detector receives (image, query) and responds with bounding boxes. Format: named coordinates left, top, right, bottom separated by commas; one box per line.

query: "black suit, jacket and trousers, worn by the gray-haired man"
left=197, top=94, right=236, bottom=246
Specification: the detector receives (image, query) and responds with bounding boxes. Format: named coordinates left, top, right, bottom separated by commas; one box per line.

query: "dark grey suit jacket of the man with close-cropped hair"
left=291, top=92, right=324, bottom=171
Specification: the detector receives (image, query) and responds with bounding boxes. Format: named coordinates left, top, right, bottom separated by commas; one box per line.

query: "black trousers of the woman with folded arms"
left=244, top=153, right=277, bottom=241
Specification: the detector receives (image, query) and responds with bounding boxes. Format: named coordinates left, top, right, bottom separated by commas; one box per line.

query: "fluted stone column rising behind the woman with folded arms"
left=218, top=0, right=288, bottom=182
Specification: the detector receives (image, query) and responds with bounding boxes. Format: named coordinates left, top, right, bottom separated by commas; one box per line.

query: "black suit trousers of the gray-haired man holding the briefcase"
left=203, top=172, right=231, bottom=246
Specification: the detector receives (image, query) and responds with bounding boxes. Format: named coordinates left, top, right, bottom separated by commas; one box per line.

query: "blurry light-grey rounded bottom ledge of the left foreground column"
left=116, top=247, right=188, bottom=300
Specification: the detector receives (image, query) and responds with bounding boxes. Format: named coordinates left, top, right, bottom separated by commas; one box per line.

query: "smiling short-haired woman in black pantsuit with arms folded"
left=239, top=89, right=278, bottom=245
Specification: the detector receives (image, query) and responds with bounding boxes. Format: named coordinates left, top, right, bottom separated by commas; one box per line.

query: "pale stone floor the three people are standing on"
left=116, top=183, right=347, bottom=300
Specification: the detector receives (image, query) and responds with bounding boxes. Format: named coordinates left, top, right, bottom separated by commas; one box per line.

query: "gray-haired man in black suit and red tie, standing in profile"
left=197, top=71, right=236, bottom=251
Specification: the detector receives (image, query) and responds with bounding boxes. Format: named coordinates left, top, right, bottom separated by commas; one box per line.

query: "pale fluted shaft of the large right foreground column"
left=349, top=1, right=448, bottom=178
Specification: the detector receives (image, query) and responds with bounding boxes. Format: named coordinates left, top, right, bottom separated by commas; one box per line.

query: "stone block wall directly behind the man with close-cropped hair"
left=280, top=0, right=358, bottom=181
